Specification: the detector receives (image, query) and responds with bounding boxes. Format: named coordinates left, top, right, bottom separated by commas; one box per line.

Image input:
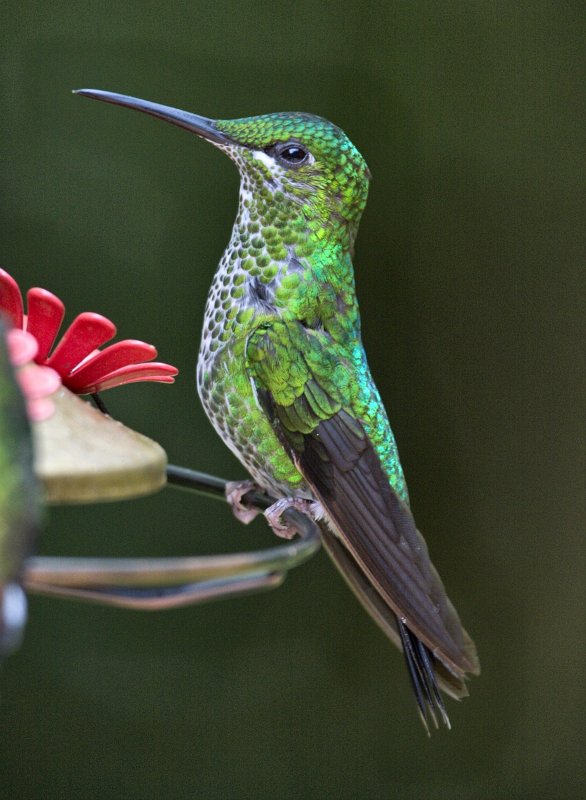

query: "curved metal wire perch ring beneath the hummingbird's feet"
left=24, top=465, right=320, bottom=611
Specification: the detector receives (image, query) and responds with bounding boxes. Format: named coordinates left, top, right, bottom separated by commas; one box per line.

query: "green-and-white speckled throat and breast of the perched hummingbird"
left=198, top=148, right=366, bottom=351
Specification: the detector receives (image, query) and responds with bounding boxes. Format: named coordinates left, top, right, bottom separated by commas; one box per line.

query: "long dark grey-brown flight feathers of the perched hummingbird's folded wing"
left=292, top=411, right=478, bottom=677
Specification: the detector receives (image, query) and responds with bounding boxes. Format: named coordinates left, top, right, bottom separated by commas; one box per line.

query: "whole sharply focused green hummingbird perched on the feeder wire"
left=76, top=89, right=479, bottom=733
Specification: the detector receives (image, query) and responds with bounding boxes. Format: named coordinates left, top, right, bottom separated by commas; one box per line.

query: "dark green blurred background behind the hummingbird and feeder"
left=0, top=0, right=586, bottom=800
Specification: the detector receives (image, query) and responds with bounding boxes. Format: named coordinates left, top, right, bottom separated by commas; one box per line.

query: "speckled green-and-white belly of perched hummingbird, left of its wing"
left=197, top=341, right=311, bottom=497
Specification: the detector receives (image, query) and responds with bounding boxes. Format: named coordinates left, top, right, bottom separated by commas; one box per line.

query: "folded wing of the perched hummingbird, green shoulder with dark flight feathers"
left=247, top=320, right=478, bottom=696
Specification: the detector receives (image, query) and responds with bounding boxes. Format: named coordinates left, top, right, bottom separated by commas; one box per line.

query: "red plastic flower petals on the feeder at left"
left=0, top=268, right=178, bottom=394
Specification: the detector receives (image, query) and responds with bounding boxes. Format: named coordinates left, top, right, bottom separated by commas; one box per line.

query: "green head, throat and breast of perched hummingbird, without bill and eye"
left=197, top=114, right=370, bottom=350
